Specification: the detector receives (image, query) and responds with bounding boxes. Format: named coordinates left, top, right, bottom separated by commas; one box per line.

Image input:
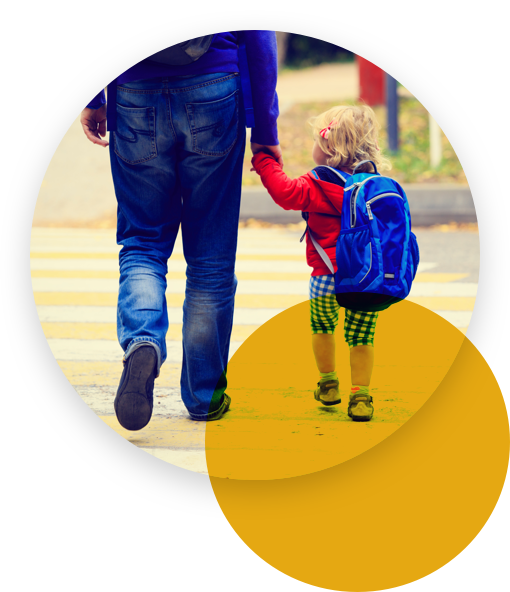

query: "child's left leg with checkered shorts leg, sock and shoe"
left=310, top=275, right=341, bottom=405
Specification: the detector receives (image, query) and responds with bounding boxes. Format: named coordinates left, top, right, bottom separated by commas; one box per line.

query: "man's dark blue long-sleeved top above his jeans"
left=86, top=30, right=279, bottom=146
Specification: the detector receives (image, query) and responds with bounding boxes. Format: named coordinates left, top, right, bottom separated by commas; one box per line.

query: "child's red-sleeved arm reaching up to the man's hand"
left=251, top=152, right=317, bottom=211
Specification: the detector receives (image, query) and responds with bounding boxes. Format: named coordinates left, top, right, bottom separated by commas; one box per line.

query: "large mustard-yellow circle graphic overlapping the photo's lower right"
left=207, top=303, right=510, bottom=592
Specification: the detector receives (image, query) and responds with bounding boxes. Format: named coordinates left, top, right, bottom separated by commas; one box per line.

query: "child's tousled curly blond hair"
left=308, top=105, right=391, bottom=173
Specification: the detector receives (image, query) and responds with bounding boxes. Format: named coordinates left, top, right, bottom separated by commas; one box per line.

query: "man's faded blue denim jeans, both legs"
left=110, top=74, right=246, bottom=420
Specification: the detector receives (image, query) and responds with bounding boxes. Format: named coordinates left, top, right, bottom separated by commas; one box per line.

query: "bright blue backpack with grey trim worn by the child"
left=301, top=160, right=420, bottom=312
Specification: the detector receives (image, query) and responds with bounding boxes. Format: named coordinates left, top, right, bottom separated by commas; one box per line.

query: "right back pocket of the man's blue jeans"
left=186, top=90, right=239, bottom=156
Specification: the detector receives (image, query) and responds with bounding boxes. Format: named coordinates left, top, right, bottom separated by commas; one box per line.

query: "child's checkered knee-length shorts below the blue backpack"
left=310, top=275, right=379, bottom=347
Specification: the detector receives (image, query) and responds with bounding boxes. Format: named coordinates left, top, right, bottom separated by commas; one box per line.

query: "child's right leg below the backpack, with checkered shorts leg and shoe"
left=344, top=309, right=379, bottom=421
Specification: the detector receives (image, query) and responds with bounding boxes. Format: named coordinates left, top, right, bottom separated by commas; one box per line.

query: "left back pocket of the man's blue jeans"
left=112, top=104, right=157, bottom=164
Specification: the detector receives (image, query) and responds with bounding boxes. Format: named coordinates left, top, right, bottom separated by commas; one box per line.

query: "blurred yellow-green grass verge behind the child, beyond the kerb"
left=243, top=97, right=468, bottom=186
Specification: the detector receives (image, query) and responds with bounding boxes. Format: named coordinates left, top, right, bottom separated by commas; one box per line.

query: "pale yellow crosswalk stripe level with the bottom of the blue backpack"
left=34, top=292, right=476, bottom=310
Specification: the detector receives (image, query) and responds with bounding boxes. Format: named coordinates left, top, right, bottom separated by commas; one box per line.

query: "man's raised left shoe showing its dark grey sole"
left=113, top=345, right=158, bottom=430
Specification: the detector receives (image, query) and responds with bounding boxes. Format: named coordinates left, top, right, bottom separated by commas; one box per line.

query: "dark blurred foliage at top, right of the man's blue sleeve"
left=283, top=32, right=354, bottom=68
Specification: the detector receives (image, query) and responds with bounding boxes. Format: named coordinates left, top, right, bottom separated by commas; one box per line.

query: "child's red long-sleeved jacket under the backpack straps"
left=252, top=152, right=344, bottom=276
